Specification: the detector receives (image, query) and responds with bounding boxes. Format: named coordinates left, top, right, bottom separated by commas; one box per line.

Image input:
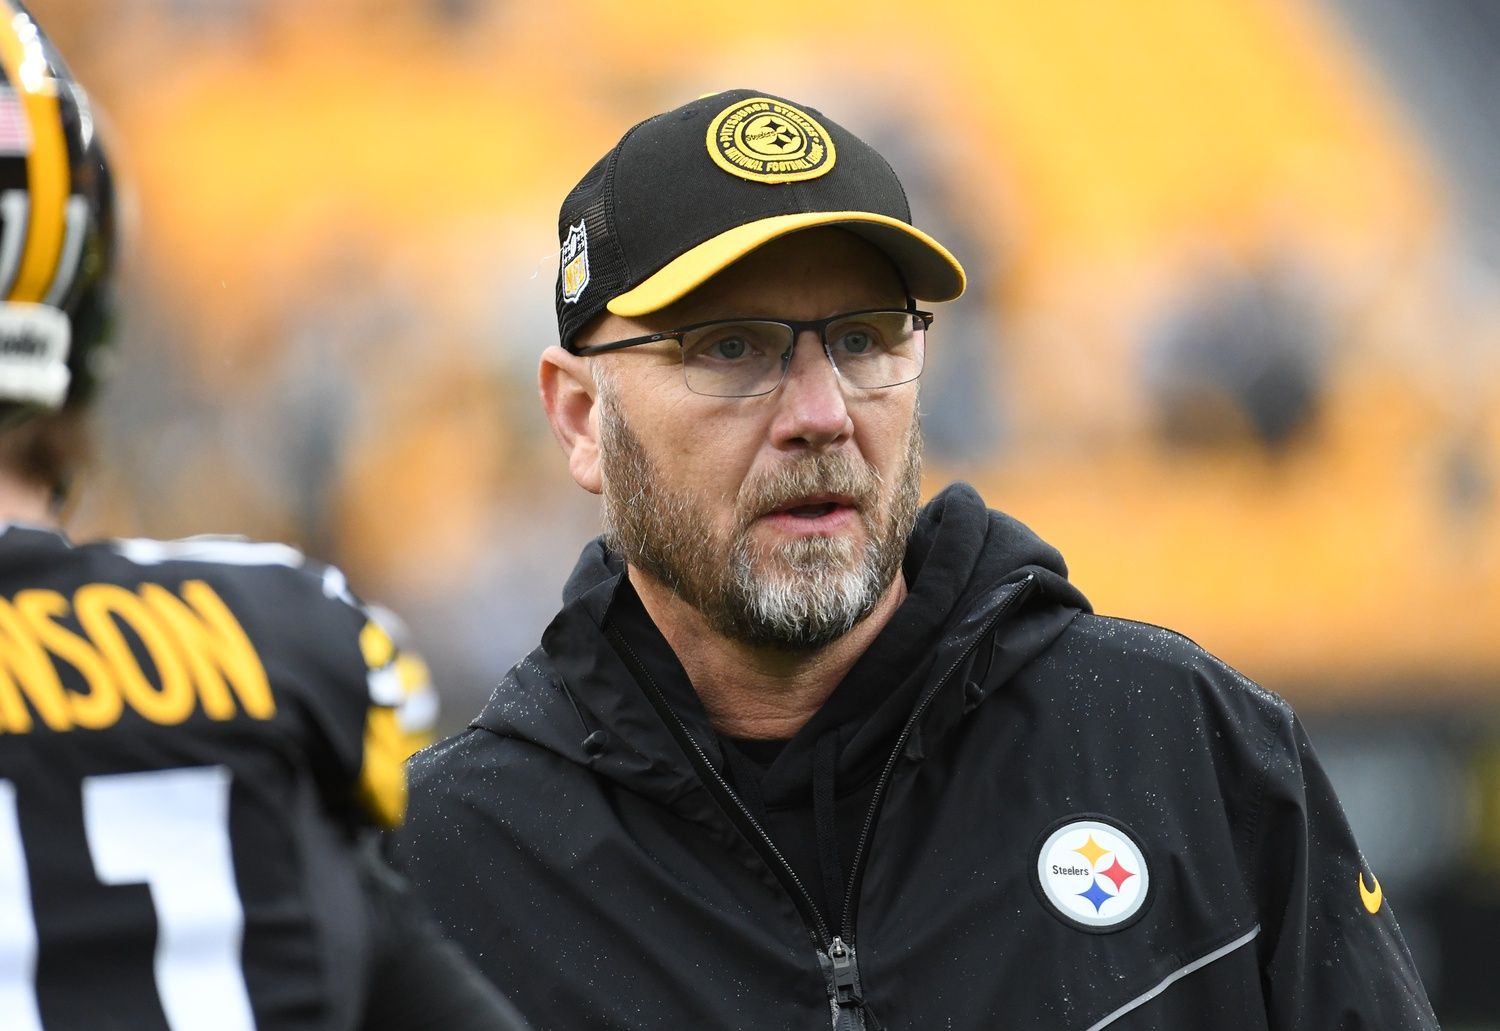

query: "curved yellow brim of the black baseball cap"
left=608, top=212, right=968, bottom=318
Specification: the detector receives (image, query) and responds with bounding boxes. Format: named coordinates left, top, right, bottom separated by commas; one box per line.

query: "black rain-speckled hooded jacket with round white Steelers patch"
left=392, top=485, right=1436, bottom=1031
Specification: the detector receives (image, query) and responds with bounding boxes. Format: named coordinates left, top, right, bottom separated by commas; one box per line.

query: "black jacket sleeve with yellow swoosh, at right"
left=1254, top=702, right=1437, bottom=1031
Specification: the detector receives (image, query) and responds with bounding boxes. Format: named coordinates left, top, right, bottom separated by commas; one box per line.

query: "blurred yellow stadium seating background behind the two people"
left=23, top=0, right=1500, bottom=1028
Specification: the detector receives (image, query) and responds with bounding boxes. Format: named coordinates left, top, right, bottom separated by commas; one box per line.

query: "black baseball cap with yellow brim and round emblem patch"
left=557, top=90, right=965, bottom=348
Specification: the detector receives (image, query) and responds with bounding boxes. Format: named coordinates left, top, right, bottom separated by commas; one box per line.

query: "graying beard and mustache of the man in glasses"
left=599, top=380, right=921, bottom=651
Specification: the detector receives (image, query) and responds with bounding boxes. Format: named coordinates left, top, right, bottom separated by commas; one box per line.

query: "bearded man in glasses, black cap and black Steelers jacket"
left=393, top=90, right=1436, bottom=1031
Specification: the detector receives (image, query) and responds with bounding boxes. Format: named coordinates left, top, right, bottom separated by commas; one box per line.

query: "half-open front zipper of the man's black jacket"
left=609, top=576, right=1037, bottom=1031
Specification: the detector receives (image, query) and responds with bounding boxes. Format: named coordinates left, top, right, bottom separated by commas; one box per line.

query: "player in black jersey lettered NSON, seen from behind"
left=0, top=0, right=524, bottom=1031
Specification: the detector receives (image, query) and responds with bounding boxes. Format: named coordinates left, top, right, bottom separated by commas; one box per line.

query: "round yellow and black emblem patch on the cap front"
left=708, top=96, right=836, bottom=183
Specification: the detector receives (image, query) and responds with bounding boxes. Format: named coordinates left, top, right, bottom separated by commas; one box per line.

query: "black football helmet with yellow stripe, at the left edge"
left=0, top=0, right=116, bottom=428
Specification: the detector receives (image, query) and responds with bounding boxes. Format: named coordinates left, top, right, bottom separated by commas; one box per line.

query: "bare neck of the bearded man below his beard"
left=630, top=566, right=906, bottom=738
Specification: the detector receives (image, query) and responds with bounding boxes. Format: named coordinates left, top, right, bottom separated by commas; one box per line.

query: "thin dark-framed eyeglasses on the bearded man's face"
left=575, top=309, right=933, bottom=398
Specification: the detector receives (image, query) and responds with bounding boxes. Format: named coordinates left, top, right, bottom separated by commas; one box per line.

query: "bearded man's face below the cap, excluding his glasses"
left=581, top=230, right=921, bottom=650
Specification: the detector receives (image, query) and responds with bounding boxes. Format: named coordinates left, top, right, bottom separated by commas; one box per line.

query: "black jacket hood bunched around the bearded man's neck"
left=471, top=483, right=1089, bottom=809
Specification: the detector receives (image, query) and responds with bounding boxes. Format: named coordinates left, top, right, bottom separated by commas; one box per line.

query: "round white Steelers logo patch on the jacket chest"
left=1032, top=813, right=1152, bottom=933
